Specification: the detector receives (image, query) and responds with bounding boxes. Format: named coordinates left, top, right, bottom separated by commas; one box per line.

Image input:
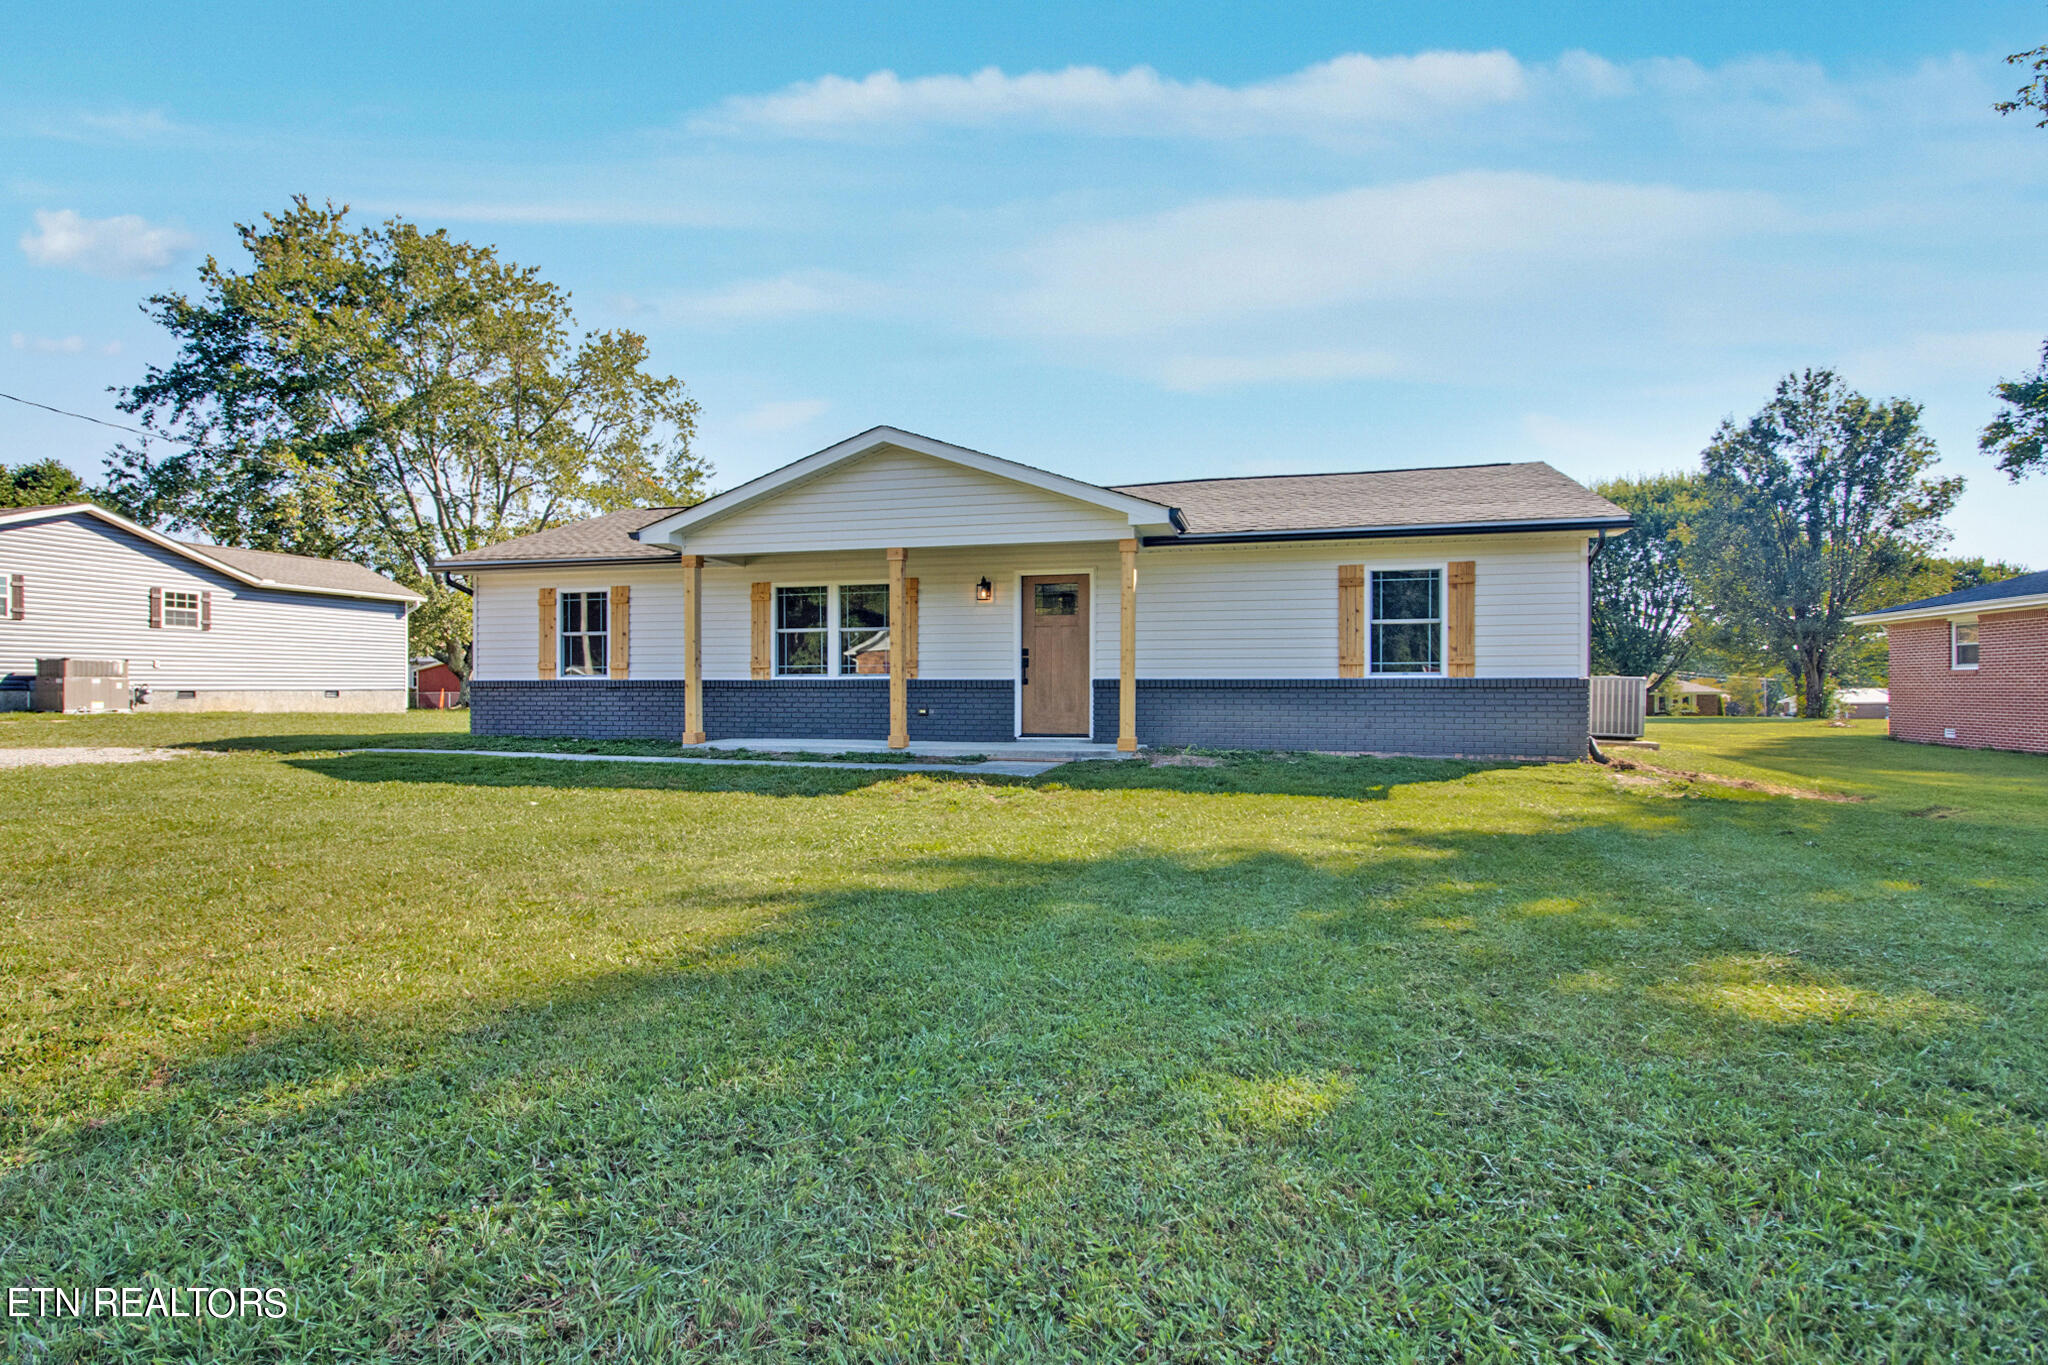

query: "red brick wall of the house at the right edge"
left=1886, top=610, right=2048, bottom=753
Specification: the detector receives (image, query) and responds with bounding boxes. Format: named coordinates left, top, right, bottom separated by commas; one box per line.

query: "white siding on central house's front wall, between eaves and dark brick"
left=471, top=532, right=1585, bottom=679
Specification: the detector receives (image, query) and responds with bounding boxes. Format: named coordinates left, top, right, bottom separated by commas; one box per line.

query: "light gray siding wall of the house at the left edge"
left=0, top=514, right=408, bottom=696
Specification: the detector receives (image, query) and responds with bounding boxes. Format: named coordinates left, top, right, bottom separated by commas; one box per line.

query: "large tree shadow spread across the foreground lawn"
left=0, top=802, right=2040, bottom=1359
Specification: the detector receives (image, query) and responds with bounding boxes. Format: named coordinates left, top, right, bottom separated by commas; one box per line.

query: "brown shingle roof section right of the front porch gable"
left=1116, top=460, right=1628, bottom=536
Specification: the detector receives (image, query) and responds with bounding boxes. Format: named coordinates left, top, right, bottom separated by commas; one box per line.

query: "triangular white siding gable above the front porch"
left=682, top=450, right=1130, bottom=555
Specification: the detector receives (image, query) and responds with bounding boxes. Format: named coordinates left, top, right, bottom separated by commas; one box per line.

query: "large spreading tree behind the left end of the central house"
left=106, top=196, right=709, bottom=675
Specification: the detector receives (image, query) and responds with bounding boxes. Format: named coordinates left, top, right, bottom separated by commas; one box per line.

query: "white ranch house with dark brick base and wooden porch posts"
left=436, top=428, right=1628, bottom=759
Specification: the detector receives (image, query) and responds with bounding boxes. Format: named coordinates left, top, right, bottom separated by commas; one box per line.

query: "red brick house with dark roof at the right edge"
left=1851, top=573, right=2048, bottom=753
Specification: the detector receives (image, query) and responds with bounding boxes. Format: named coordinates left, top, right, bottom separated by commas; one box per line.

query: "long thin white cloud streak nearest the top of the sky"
left=692, top=51, right=1526, bottom=137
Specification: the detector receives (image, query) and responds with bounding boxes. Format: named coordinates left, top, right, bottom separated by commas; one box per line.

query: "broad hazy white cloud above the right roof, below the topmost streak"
left=1006, top=172, right=1782, bottom=336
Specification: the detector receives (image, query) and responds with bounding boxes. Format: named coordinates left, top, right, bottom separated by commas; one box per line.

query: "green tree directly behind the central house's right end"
left=1593, top=475, right=1704, bottom=690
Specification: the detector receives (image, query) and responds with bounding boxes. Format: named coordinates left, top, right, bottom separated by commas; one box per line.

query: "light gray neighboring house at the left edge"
left=0, top=503, right=422, bottom=710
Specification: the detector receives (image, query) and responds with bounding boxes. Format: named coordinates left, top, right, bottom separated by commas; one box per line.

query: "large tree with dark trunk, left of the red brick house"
left=1688, top=370, right=1962, bottom=718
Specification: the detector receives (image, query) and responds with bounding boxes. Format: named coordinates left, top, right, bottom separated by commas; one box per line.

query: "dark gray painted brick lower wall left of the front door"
left=469, top=677, right=1016, bottom=743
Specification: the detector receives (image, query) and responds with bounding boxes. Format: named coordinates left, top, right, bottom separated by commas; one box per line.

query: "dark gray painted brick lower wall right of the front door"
left=1096, top=677, right=1587, bottom=759
